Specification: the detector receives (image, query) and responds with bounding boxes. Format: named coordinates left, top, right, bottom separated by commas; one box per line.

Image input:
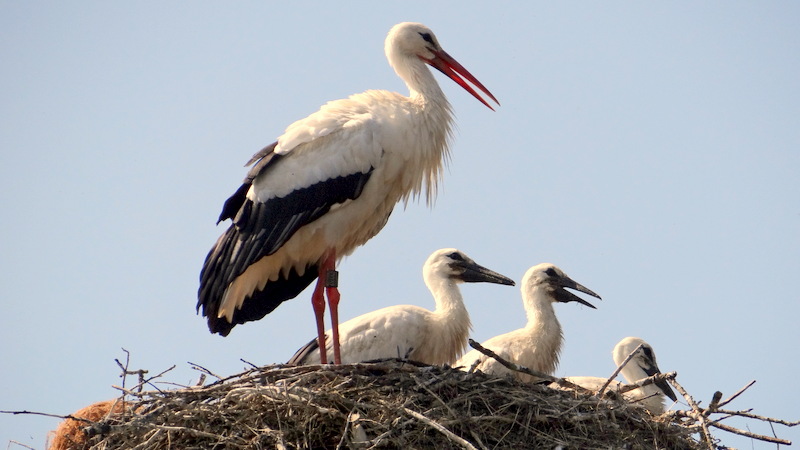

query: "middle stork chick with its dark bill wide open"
left=456, top=263, right=600, bottom=381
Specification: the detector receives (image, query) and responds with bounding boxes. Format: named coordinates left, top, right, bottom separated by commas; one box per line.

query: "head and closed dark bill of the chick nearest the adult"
left=422, top=248, right=514, bottom=286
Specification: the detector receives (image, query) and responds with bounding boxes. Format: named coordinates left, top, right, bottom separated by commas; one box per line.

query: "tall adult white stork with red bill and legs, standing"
left=197, top=23, right=497, bottom=363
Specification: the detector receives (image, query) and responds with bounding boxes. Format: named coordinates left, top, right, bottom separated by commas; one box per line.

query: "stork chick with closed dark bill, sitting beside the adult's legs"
left=289, top=248, right=514, bottom=365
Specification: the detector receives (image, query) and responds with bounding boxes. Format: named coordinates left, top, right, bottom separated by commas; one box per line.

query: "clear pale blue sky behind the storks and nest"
left=0, top=1, right=800, bottom=449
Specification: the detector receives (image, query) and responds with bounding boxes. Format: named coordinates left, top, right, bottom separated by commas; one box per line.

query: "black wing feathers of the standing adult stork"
left=197, top=144, right=372, bottom=335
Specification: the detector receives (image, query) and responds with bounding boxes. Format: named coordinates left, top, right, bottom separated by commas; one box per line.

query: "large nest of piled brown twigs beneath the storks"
left=53, top=360, right=705, bottom=450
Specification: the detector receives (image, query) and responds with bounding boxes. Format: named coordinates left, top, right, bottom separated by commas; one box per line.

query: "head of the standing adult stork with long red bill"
left=384, top=22, right=500, bottom=109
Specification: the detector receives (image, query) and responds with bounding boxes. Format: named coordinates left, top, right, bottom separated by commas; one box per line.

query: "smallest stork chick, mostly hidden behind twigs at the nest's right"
left=552, top=337, right=678, bottom=414
